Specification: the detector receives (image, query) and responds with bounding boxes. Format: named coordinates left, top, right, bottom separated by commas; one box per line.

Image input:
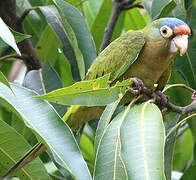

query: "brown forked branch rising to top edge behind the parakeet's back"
left=99, top=0, right=143, bottom=52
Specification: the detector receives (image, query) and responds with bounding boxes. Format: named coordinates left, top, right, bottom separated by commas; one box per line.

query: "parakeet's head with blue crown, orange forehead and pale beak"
left=144, top=18, right=191, bottom=56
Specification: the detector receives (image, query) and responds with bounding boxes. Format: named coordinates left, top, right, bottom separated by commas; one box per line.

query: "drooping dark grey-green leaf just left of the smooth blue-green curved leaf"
left=40, top=6, right=81, bottom=81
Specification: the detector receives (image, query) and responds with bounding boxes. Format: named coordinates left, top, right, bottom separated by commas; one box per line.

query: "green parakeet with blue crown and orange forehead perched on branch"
left=64, top=18, right=191, bottom=128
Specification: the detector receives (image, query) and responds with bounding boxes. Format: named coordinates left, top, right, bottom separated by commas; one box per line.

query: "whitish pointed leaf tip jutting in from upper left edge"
left=0, top=18, right=21, bottom=55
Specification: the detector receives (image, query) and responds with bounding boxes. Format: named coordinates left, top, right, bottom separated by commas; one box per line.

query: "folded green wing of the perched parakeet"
left=86, top=31, right=145, bottom=81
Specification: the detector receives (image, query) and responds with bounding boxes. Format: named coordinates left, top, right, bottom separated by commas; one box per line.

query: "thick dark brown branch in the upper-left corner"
left=0, top=0, right=41, bottom=70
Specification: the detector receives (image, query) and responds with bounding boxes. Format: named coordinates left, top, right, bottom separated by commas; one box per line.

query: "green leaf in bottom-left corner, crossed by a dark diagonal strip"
left=0, top=120, right=50, bottom=180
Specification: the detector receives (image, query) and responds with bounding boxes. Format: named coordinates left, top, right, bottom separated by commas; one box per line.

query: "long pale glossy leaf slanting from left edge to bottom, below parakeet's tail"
left=0, top=83, right=91, bottom=180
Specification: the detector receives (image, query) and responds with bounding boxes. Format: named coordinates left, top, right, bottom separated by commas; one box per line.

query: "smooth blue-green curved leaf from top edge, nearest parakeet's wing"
left=53, top=0, right=97, bottom=72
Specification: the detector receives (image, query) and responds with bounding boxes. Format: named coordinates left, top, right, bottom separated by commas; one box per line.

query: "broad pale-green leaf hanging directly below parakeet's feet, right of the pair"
left=119, top=103, right=165, bottom=180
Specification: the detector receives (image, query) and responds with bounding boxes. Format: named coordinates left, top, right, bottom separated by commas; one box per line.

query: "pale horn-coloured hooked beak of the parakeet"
left=170, top=34, right=188, bottom=56
